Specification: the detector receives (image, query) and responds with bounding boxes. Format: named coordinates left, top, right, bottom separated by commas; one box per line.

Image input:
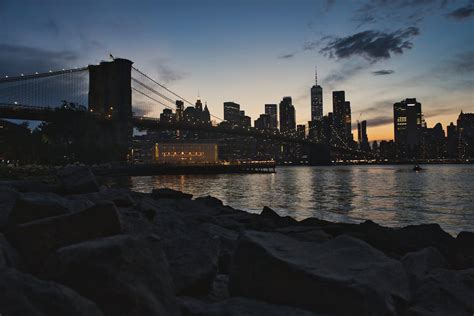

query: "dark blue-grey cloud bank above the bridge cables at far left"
left=0, top=43, right=79, bottom=76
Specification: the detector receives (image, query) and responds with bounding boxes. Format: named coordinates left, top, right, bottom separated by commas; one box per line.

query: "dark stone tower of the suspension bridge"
left=88, top=58, right=133, bottom=160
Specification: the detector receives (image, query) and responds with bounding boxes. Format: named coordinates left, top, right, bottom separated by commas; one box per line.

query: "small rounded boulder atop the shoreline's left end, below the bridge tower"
left=57, top=166, right=99, bottom=194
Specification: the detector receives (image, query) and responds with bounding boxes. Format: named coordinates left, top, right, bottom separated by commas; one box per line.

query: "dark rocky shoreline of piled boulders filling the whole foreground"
left=0, top=167, right=474, bottom=316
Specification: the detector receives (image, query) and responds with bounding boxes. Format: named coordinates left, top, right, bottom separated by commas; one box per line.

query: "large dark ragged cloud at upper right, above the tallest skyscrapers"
left=320, top=26, right=420, bottom=63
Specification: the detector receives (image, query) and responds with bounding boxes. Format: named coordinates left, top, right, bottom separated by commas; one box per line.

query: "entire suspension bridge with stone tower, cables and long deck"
left=0, top=58, right=369, bottom=164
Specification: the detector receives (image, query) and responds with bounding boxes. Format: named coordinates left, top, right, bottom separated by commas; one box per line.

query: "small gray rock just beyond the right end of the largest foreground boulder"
left=401, top=247, right=447, bottom=283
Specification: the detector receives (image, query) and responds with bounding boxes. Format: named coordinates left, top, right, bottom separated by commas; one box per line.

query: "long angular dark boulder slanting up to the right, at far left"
left=7, top=202, right=122, bottom=271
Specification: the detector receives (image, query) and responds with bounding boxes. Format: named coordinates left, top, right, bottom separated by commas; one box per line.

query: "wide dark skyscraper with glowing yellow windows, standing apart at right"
left=393, top=98, right=424, bottom=158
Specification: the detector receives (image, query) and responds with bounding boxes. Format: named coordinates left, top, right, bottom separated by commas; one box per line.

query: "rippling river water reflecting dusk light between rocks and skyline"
left=113, top=165, right=474, bottom=234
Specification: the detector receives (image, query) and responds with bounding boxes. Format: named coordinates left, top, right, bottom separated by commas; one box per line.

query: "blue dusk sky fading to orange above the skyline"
left=0, top=0, right=474, bottom=140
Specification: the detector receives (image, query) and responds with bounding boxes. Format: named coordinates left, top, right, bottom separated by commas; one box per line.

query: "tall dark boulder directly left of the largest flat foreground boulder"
left=145, top=201, right=219, bottom=295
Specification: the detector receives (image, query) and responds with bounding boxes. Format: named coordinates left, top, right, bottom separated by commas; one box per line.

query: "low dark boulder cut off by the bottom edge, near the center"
left=180, top=297, right=315, bottom=316
